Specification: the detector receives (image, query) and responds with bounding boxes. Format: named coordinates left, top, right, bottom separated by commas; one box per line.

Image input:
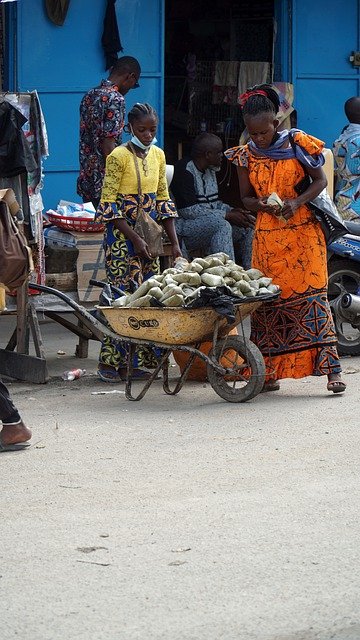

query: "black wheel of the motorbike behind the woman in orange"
left=328, top=258, right=360, bottom=356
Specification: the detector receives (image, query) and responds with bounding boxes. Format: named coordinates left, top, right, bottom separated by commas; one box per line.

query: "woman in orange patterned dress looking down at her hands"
left=225, top=85, right=346, bottom=393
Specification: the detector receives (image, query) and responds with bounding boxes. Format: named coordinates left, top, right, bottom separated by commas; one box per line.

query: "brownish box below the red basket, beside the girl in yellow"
left=71, top=231, right=106, bottom=302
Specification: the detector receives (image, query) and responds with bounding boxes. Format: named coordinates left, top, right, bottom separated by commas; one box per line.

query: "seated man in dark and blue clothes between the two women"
left=171, top=133, right=255, bottom=269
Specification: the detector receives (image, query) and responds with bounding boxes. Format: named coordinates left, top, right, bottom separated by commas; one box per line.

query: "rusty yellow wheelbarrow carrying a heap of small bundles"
left=31, top=285, right=278, bottom=402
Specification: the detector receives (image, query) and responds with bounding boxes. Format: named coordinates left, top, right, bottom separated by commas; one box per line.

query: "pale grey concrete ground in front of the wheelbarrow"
left=0, top=318, right=360, bottom=640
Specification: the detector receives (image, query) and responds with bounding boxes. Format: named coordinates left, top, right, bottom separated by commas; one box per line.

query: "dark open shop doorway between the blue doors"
left=164, top=0, right=275, bottom=164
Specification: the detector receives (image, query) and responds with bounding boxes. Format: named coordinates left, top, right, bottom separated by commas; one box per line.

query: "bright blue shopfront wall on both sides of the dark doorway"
left=13, top=0, right=360, bottom=208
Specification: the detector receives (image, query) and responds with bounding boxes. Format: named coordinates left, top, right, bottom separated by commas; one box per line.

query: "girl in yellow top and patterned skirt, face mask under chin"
left=96, top=103, right=181, bottom=382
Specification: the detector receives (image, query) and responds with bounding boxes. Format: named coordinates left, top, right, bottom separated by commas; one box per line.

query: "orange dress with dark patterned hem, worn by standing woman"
left=225, top=132, right=341, bottom=380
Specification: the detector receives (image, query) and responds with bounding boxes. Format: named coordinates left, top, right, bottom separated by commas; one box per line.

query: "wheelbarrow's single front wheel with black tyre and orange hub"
left=207, top=336, right=265, bottom=402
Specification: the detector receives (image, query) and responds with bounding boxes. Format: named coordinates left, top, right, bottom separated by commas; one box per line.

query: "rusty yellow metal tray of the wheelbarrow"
left=97, top=298, right=263, bottom=345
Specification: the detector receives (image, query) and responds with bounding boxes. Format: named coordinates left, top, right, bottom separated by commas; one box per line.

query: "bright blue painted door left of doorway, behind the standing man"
left=14, top=0, right=164, bottom=208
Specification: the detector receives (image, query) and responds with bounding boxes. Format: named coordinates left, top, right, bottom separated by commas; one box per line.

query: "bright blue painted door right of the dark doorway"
left=292, top=0, right=360, bottom=147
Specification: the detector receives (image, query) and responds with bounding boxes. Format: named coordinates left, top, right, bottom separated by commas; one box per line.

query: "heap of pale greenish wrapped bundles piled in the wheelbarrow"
left=113, top=253, right=279, bottom=307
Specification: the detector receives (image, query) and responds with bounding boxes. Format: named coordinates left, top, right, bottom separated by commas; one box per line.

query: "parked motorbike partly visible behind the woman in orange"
left=328, top=221, right=360, bottom=356
